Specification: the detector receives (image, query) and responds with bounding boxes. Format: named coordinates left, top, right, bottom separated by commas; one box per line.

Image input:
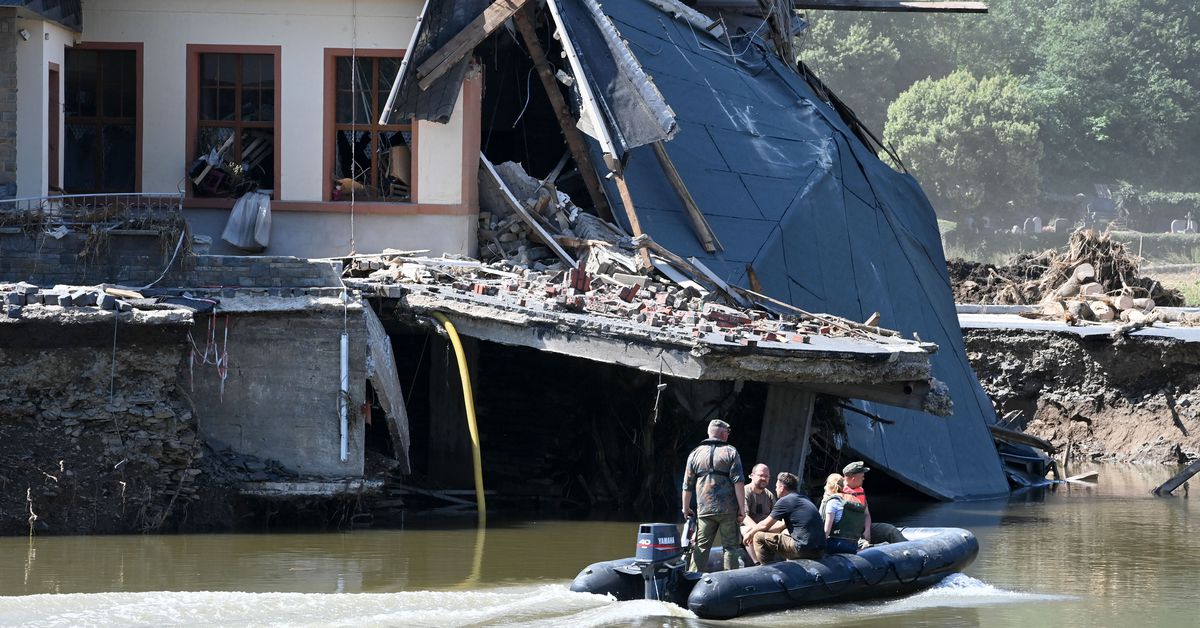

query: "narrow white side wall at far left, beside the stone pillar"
left=17, top=17, right=74, bottom=197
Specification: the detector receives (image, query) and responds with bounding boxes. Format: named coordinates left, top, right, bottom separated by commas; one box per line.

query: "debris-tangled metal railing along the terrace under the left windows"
left=0, top=192, right=184, bottom=231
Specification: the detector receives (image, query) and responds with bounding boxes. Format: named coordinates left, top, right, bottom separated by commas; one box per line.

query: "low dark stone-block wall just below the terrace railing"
left=0, top=227, right=342, bottom=295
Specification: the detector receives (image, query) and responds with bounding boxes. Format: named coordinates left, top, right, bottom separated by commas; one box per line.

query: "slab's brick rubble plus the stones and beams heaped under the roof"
left=346, top=162, right=896, bottom=348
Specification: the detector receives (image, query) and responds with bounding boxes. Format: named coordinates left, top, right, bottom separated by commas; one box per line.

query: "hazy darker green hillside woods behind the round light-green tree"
left=800, top=0, right=1200, bottom=193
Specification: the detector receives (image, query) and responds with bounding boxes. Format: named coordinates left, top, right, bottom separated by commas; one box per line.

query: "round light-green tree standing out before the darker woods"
left=883, top=71, right=1043, bottom=222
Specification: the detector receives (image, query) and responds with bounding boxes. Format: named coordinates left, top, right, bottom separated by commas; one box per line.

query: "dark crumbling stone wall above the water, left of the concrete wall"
left=0, top=312, right=212, bottom=534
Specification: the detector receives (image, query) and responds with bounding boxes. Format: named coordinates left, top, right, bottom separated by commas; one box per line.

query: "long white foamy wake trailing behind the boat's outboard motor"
left=0, top=585, right=695, bottom=628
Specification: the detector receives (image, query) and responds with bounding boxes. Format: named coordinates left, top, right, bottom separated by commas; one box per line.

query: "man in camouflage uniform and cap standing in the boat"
left=683, top=419, right=749, bottom=572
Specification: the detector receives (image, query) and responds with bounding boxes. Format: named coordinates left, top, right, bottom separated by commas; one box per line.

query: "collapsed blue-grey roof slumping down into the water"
left=391, top=0, right=1008, bottom=498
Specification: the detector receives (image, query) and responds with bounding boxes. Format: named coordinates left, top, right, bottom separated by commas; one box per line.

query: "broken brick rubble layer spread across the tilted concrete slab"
left=346, top=241, right=895, bottom=348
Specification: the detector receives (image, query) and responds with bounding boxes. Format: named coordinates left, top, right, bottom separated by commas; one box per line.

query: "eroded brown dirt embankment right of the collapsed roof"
left=964, top=329, right=1200, bottom=463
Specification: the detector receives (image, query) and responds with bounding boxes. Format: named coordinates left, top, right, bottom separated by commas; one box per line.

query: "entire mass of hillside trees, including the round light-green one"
left=800, top=0, right=1200, bottom=219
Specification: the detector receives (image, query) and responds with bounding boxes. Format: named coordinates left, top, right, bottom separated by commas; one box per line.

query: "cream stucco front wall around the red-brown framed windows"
left=76, top=0, right=462, bottom=203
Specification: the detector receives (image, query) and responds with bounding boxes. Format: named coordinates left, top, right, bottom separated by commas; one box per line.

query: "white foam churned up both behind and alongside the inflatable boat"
left=0, top=581, right=1073, bottom=628
